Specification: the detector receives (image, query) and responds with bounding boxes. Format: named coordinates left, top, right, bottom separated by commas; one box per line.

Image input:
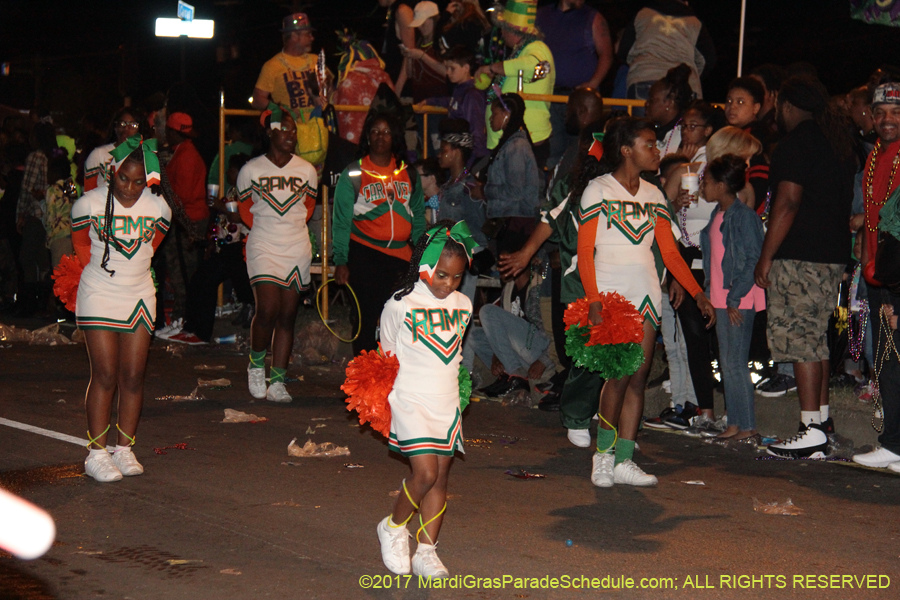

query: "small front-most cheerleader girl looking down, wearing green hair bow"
left=377, top=221, right=476, bottom=577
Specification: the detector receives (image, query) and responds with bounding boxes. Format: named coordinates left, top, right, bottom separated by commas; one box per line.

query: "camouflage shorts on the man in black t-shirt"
left=766, top=260, right=844, bottom=362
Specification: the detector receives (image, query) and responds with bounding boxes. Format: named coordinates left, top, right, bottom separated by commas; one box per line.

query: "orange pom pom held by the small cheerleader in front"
left=341, top=348, right=400, bottom=437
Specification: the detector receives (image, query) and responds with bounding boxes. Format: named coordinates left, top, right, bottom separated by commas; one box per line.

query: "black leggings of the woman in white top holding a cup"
left=677, top=244, right=715, bottom=410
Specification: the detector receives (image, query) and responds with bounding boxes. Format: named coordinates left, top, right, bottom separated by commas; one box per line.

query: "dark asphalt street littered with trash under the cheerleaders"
left=0, top=343, right=900, bottom=600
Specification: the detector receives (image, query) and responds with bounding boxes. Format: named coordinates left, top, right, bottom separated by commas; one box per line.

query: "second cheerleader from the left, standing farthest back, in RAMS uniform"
left=237, top=103, right=317, bottom=402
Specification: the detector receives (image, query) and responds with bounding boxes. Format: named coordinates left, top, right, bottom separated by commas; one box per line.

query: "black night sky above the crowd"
left=0, top=0, right=900, bottom=127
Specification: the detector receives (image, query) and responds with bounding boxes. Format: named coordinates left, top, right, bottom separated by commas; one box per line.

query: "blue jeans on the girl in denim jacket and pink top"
left=716, top=308, right=756, bottom=431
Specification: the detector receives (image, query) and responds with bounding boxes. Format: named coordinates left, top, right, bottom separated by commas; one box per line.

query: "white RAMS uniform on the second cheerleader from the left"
left=237, top=155, right=317, bottom=292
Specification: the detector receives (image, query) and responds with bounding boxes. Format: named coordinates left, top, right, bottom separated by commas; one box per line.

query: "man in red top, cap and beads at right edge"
left=853, top=81, right=900, bottom=473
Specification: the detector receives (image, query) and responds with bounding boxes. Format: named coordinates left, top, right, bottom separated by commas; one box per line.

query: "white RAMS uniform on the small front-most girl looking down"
left=381, top=280, right=472, bottom=456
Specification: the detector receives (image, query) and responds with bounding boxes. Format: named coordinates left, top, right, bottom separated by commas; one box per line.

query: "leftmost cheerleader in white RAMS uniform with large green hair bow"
left=72, top=136, right=189, bottom=482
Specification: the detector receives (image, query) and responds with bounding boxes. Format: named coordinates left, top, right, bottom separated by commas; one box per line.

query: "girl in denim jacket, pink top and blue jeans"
left=700, top=154, right=766, bottom=440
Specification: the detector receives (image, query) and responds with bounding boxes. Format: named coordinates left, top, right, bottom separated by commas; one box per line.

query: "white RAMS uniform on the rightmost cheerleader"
left=580, top=174, right=672, bottom=326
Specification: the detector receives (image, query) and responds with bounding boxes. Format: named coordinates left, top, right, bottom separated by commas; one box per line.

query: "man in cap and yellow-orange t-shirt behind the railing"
left=252, top=13, right=321, bottom=116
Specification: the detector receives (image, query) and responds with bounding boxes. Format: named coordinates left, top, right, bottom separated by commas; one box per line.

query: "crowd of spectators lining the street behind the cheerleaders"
left=0, top=0, right=900, bottom=470
